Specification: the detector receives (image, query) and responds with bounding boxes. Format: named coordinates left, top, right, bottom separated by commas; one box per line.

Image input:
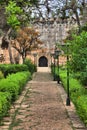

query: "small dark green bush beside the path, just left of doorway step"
left=24, top=59, right=37, bottom=73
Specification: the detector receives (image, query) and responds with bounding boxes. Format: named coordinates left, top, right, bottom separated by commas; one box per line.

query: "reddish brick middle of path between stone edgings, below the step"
left=12, top=82, right=73, bottom=130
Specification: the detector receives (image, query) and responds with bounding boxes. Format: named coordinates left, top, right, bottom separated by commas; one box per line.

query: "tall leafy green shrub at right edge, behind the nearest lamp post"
left=70, top=32, right=87, bottom=85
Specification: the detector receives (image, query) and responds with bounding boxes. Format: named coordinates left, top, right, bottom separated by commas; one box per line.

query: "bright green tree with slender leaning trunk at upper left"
left=2, top=1, right=23, bottom=63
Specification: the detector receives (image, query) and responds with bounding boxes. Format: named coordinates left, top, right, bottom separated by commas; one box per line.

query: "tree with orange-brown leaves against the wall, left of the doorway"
left=11, top=27, right=42, bottom=62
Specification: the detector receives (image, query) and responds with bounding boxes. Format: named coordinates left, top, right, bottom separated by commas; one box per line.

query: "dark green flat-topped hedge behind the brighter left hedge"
left=0, top=64, right=28, bottom=77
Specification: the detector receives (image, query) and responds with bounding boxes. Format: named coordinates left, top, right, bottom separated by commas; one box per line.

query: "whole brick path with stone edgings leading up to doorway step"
left=0, top=72, right=87, bottom=130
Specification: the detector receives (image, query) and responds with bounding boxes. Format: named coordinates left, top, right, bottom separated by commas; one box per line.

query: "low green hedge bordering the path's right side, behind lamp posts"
left=59, top=70, right=87, bottom=126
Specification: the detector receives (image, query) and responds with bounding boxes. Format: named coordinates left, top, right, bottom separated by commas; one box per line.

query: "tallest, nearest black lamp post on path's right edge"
left=66, top=44, right=70, bottom=106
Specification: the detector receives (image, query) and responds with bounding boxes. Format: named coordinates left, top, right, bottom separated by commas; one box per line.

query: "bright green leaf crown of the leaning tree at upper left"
left=6, top=1, right=23, bottom=28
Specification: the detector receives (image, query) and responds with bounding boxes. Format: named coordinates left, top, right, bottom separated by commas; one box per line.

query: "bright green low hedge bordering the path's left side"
left=0, top=71, right=31, bottom=119
